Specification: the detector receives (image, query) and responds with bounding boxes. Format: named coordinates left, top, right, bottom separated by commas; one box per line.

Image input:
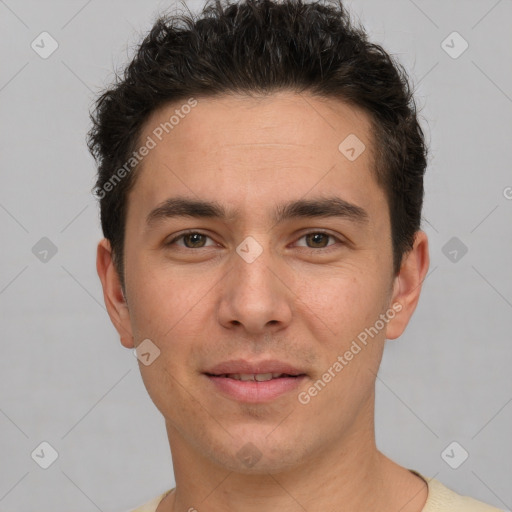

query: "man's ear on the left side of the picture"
left=96, top=238, right=134, bottom=348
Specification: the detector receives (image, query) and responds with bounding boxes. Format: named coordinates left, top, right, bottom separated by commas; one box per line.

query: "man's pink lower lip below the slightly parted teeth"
left=206, top=375, right=306, bottom=403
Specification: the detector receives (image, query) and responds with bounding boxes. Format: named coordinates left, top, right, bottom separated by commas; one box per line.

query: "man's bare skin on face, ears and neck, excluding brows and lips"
left=97, top=92, right=429, bottom=512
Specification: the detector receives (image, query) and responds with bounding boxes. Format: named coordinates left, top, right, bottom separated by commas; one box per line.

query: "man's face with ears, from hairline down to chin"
left=98, top=93, right=428, bottom=472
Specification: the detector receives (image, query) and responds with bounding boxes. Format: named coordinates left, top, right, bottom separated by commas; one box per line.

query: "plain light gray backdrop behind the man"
left=0, top=0, right=512, bottom=512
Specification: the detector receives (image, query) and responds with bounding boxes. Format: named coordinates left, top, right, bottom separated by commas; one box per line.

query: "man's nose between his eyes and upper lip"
left=218, top=241, right=295, bottom=336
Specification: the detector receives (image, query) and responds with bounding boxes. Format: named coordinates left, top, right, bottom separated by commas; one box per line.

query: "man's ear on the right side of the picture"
left=386, top=231, right=430, bottom=340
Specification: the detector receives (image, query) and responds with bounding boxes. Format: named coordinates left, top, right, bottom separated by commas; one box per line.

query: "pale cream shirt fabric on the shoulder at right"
left=422, top=477, right=503, bottom=512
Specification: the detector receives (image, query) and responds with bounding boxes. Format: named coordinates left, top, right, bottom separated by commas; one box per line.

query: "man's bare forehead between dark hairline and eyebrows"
left=128, top=92, right=385, bottom=229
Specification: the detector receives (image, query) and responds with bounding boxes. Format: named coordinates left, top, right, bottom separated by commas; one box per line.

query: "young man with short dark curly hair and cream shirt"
left=89, top=0, right=504, bottom=512
